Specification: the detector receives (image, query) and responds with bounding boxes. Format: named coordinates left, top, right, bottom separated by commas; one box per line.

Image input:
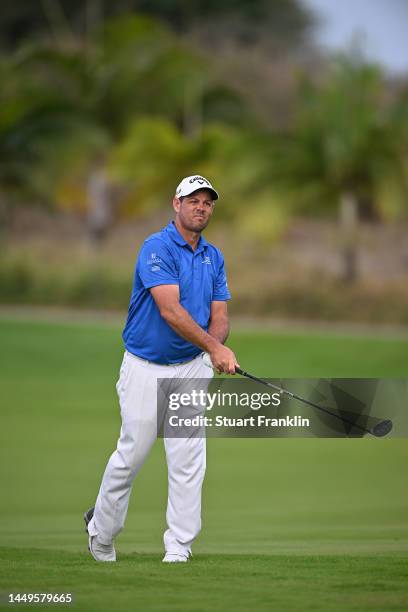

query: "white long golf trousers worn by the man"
left=88, top=352, right=213, bottom=555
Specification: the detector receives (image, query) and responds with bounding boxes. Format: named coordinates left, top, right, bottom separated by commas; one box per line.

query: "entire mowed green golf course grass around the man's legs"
left=0, top=320, right=408, bottom=611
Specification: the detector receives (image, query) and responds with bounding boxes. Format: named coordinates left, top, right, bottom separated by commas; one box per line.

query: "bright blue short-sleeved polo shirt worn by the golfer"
left=123, top=221, right=231, bottom=364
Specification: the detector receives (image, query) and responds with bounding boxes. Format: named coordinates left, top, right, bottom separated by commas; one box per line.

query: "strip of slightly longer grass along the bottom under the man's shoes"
left=0, top=549, right=407, bottom=612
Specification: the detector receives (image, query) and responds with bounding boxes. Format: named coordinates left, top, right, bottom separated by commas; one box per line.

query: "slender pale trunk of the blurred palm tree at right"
left=340, top=192, right=358, bottom=283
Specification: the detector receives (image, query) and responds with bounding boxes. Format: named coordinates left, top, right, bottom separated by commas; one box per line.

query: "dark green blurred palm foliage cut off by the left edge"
left=0, top=58, right=96, bottom=237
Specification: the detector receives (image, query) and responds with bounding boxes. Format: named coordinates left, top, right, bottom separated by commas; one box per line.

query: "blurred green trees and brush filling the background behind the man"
left=0, top=0, right=408, bottom=323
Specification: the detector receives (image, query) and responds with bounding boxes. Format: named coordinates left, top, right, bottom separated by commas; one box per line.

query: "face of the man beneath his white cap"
left=173, top=189, right=214, bottom=232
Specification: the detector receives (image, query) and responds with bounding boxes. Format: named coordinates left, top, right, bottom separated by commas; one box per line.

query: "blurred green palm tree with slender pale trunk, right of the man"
left=270, top=57, right=408, bottom=281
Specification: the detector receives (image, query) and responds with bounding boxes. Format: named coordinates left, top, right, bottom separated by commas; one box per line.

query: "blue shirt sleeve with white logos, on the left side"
left=138, top=239, right=179, bottom=289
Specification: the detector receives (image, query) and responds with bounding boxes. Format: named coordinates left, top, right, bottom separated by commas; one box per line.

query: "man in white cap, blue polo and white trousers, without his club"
left=84, top=176, right=239, bottom=562
